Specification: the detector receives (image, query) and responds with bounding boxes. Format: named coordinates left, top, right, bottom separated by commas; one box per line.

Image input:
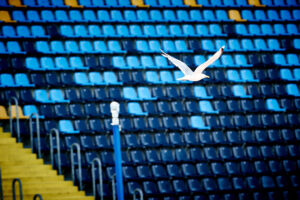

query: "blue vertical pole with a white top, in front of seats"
left=110, top=102, right=124, bottom=200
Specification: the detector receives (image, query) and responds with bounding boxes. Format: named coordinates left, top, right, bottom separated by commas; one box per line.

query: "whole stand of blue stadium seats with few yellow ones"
left=0, top=0, right=300, bottom=200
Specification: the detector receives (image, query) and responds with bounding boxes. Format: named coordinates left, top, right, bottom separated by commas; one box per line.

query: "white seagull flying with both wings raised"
left=161, top=46, right=225, bottom=81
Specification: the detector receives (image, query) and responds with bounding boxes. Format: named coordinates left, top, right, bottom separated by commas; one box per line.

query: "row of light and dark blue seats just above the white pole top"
left=14, top=83, right=299, bottom=103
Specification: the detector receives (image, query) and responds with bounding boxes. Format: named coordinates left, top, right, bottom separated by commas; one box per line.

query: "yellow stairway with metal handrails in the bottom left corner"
left=0, top=127, right=94, bottom=200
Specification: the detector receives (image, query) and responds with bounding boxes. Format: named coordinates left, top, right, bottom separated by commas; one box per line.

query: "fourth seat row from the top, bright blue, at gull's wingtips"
left=0, top=38, right=300, bottom=58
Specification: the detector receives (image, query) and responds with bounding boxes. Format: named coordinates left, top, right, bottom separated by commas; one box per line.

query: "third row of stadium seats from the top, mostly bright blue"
left=2, top=24, right=299, bottom=38
